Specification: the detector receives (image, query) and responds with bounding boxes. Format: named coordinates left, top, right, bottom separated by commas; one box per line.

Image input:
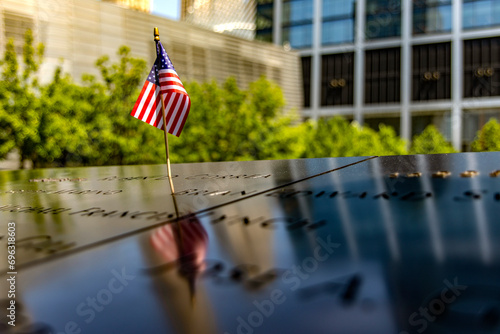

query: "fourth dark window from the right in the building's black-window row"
left=321, top=52, right=354, bottom=106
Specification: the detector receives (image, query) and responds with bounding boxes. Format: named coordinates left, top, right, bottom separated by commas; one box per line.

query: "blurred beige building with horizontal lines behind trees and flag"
left=0, top=0, right=303, bottom=110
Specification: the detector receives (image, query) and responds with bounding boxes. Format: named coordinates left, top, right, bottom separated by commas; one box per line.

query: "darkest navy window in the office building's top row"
left=365, top=0, right=401, bottom=39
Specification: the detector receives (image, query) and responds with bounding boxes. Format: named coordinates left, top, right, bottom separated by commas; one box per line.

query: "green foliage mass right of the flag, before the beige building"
left=171, top=77, right=299, bottom=162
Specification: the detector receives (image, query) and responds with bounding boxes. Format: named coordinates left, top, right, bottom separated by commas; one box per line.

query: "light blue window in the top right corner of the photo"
left=462, top=0, right=500, bottom=29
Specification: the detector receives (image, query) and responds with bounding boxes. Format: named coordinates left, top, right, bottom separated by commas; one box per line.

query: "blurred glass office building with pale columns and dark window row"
left=256, top=0, right=500, bottom=149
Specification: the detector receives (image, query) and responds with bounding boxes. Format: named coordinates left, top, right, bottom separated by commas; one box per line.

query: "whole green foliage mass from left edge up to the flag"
left=0, top=31, right=163, bottom=167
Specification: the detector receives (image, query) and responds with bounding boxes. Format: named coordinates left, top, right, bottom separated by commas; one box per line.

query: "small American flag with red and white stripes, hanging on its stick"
left=131, top=41, right=191, bottom=137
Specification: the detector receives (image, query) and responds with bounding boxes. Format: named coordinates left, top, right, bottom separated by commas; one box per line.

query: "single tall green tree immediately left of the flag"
left=86, top=46, right=165, bottom=165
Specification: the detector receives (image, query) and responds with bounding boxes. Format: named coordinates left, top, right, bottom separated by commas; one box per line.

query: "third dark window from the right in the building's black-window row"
left=365, top=48, right=401, bottom=103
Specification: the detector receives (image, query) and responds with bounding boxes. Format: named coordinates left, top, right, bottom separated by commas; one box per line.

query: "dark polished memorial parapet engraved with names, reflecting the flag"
left=0, top=153, right=500, bottom=334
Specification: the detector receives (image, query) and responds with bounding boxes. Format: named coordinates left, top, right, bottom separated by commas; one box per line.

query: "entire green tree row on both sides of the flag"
left=0, top=31, right=302, bottom=167
